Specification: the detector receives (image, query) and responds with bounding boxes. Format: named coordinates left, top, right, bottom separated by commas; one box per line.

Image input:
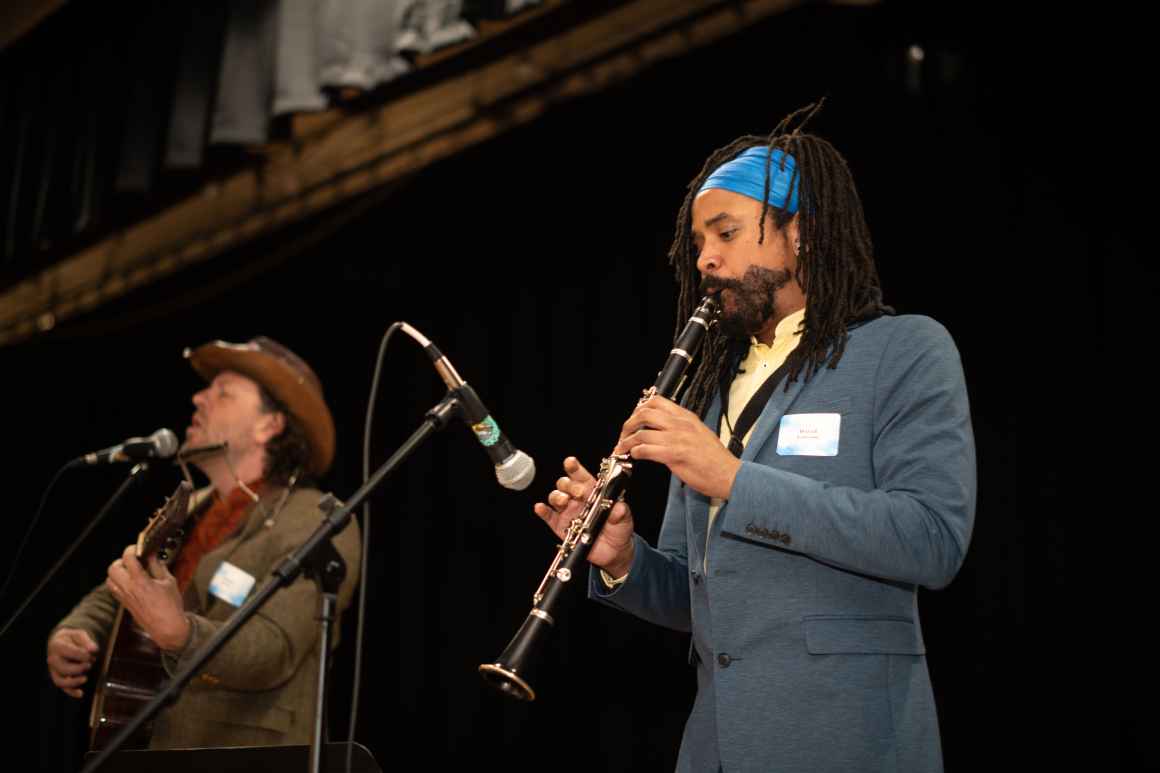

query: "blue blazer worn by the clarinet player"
left=589, top=316, right=976, bottom=773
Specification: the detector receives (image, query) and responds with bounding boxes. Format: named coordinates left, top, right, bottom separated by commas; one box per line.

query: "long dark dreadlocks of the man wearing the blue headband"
left=668, top=100, right=893, bottom=416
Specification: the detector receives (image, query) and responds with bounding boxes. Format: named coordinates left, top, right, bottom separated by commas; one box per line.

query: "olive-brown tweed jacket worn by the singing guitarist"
left=57, top=487, right=360, bottom=749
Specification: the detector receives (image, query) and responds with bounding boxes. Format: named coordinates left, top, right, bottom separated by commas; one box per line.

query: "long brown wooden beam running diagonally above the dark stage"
left=0, top=0, right=802, bottom=346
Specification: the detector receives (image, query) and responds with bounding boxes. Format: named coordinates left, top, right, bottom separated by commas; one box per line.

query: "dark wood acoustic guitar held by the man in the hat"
left=88, top=481, right=193, bottom=751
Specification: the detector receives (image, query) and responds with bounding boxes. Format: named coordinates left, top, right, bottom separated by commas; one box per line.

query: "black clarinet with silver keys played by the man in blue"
left=479, top=295, right=719, bottom=701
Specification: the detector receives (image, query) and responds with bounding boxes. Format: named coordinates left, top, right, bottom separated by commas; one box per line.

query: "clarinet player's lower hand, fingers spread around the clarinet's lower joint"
left=532, top=456, right=636, bottom=577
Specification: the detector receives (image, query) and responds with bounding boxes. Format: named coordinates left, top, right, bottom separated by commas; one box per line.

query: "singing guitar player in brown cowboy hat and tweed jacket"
left=48, top=337, right=360, bottom=749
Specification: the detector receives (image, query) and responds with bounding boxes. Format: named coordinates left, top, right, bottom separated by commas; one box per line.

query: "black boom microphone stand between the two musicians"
left=81, top=392, right=461, bottom=773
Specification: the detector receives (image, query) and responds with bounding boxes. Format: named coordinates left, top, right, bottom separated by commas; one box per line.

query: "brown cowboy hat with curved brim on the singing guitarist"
left=184, top=341, right=335, bottom=476
